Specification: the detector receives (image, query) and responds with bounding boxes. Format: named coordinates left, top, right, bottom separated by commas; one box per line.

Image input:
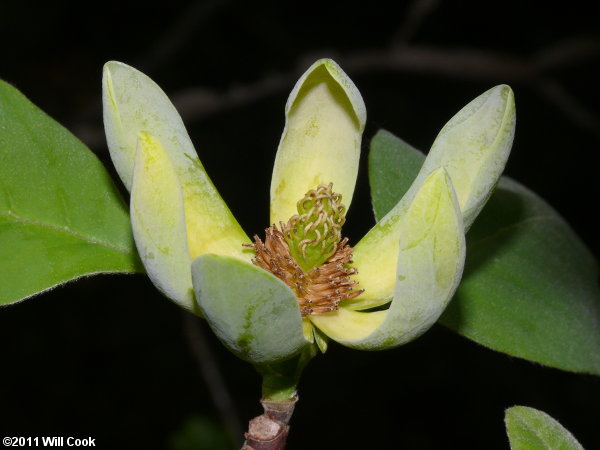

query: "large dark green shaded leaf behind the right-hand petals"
left=369, top=131, right=600, bottom=374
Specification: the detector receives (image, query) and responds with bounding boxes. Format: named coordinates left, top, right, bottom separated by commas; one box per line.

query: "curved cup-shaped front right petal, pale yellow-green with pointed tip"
left=310, top=169, right=465, bottom=350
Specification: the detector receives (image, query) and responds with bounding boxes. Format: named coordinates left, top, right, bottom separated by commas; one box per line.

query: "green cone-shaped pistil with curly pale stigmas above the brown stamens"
left=283, top=183, right=346, bottom=271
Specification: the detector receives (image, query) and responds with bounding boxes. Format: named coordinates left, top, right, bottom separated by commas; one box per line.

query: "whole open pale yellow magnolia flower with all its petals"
left=103, top=59, right=515, bottom=364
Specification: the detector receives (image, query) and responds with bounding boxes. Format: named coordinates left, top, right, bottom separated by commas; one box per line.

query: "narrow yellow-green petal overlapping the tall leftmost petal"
left=131, top=133, right=195, bottom=310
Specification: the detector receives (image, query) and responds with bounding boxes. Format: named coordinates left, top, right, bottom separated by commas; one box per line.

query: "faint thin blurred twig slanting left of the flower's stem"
left=182, top=311, right=242, bottom=448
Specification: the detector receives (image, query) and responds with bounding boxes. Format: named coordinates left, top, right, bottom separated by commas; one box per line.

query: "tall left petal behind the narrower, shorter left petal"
left=103, top=61, right=250, bottom=260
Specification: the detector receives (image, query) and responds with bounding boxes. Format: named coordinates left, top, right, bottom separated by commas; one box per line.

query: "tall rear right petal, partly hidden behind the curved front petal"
left=348, top=85, right=516, bottom=309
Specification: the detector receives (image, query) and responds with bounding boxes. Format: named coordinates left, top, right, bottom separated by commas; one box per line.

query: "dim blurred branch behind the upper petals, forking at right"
left=73, top=36, right=600, bottom=148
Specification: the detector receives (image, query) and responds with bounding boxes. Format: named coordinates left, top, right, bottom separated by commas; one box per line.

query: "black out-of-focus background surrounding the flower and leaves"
left=0, top=0, right=600, bottom=450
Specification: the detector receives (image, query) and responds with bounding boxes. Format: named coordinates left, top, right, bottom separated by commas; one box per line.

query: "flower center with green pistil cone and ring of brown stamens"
left=247, top=183, right=363, bottom=317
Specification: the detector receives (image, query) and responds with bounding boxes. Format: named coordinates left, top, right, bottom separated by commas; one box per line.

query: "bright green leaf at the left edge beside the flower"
left=0, top=81, right=143, bottom=305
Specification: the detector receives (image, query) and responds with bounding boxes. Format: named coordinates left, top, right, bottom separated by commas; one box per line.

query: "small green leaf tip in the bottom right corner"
left=504, top=406, right=583, bottom=450
